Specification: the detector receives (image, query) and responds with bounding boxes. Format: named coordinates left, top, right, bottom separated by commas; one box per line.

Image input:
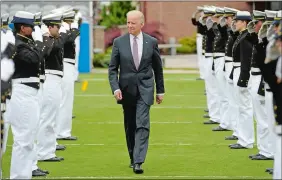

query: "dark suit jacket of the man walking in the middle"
left=109, top=33, right=165, bottom=105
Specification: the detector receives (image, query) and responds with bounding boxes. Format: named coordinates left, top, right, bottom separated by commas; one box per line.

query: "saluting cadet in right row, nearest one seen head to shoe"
left=248, top=10, right=274, bottom=160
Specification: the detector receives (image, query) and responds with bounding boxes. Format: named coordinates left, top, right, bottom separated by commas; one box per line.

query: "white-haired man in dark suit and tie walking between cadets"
left=109, top=10, right=165, bottom=174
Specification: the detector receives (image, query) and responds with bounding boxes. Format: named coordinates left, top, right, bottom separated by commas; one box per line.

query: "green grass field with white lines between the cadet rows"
left=3, top=74, right=273, bottom=179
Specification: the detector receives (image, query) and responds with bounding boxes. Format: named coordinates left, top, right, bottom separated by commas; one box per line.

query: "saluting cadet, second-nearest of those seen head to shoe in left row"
left=37, top=13, right=77, bottom=161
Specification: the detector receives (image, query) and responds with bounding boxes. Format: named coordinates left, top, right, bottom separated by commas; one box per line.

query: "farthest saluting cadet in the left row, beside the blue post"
left=56, top=11, right=79, bottom=140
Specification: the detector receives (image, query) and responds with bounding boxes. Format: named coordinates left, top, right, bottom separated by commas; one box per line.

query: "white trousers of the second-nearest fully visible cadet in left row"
left=37, top=74, right=62, bottom=160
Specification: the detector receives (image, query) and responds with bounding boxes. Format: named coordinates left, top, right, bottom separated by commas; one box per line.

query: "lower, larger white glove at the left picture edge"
left=1, top=57, right=15, bottom=82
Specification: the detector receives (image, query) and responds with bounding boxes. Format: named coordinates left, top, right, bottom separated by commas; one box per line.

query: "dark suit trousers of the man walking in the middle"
left=122, top=87, right=150, bottom=164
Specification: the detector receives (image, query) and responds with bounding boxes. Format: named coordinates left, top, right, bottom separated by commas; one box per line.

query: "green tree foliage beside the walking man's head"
left=99, top=1, right=135, bottom=28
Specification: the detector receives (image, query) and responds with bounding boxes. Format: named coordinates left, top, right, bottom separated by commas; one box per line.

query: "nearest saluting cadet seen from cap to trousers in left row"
left=8, top=11, right=48, bottom=179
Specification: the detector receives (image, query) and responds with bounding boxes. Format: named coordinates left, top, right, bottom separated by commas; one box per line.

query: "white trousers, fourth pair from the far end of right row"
left=224, top=62, right=239, bottom=136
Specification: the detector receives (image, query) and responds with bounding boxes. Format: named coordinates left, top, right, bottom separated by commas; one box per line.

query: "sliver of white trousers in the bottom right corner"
left=273, top=135, right=282, bottom=179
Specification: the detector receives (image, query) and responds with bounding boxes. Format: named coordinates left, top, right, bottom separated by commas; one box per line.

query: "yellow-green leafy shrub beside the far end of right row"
left=176, top=36, right=197, bottom=54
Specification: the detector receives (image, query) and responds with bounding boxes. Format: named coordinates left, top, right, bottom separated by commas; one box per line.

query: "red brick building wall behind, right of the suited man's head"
left=140, top=1, right=253, bottom=39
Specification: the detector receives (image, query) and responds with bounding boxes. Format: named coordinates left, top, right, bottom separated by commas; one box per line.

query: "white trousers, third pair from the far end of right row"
left=214, top=56, right=231, bottom=130
